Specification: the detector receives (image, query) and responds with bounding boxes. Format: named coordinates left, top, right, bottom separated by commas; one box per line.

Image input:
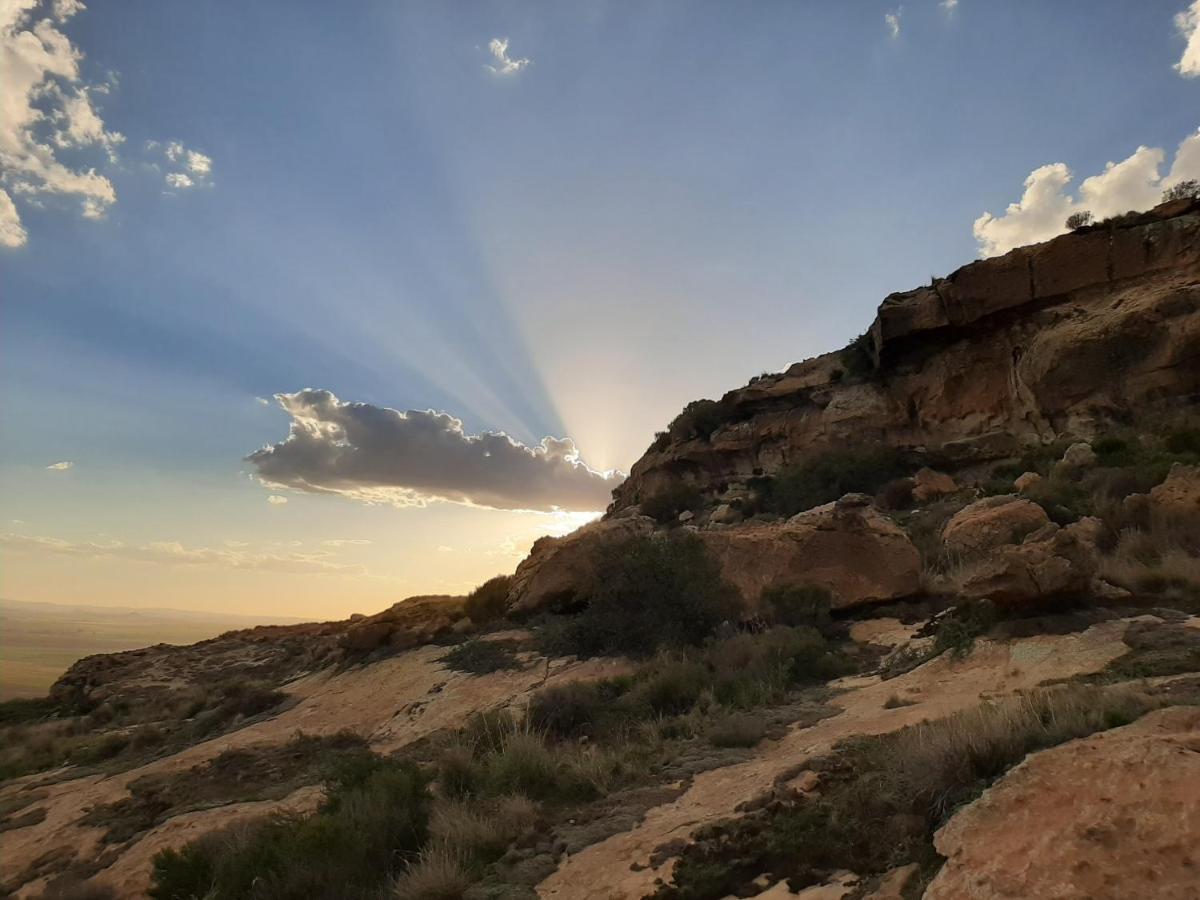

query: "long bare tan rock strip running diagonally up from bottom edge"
left=538, top=620, right=1142, bottom=900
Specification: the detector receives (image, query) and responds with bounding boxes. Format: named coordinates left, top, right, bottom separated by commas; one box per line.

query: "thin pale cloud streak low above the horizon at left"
left=0, top=532, right=367, bottom=575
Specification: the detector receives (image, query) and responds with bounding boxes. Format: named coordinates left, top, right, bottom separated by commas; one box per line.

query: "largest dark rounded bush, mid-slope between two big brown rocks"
left=541, top=534, right=739, bottom=656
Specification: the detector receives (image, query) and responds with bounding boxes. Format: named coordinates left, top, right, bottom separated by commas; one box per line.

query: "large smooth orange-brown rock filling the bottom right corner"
left=925, top=707, right=1200, bottom=900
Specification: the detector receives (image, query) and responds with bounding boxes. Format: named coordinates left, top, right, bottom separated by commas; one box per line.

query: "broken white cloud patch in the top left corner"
left=0, top=0, right=125, bottom=247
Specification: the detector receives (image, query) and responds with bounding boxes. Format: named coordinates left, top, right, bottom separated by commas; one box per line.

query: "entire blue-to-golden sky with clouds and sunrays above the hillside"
left=0, top=0, right=1200, bottom=618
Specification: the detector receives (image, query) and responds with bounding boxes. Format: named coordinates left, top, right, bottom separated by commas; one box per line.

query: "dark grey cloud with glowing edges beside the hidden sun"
left=246, top=389, right=622, bottom=511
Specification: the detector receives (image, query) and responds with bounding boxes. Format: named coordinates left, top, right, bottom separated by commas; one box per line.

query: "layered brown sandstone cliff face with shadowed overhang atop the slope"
left=611, top=200, right=1200, bottom=511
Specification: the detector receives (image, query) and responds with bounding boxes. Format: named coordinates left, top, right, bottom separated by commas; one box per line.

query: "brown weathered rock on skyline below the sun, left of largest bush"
left=509, top=516, right=654, bottom=611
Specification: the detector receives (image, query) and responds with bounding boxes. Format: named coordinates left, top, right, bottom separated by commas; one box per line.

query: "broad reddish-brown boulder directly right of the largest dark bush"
left=701, top=494, right=920, bottom=611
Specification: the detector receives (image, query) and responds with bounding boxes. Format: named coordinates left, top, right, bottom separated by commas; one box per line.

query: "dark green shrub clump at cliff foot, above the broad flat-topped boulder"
left=762, top=446, right=912, bottom=516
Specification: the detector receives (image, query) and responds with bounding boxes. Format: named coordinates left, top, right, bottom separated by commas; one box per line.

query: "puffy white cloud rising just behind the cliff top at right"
left=973, top=127, right=1200, bottom=257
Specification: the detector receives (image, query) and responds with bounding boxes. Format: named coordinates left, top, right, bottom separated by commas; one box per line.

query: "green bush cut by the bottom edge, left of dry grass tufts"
left=149, top=757, right=430, bottom=900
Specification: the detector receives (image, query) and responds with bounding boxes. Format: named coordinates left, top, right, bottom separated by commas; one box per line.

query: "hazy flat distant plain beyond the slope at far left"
left=0, top=599, right=300, bottom=701
